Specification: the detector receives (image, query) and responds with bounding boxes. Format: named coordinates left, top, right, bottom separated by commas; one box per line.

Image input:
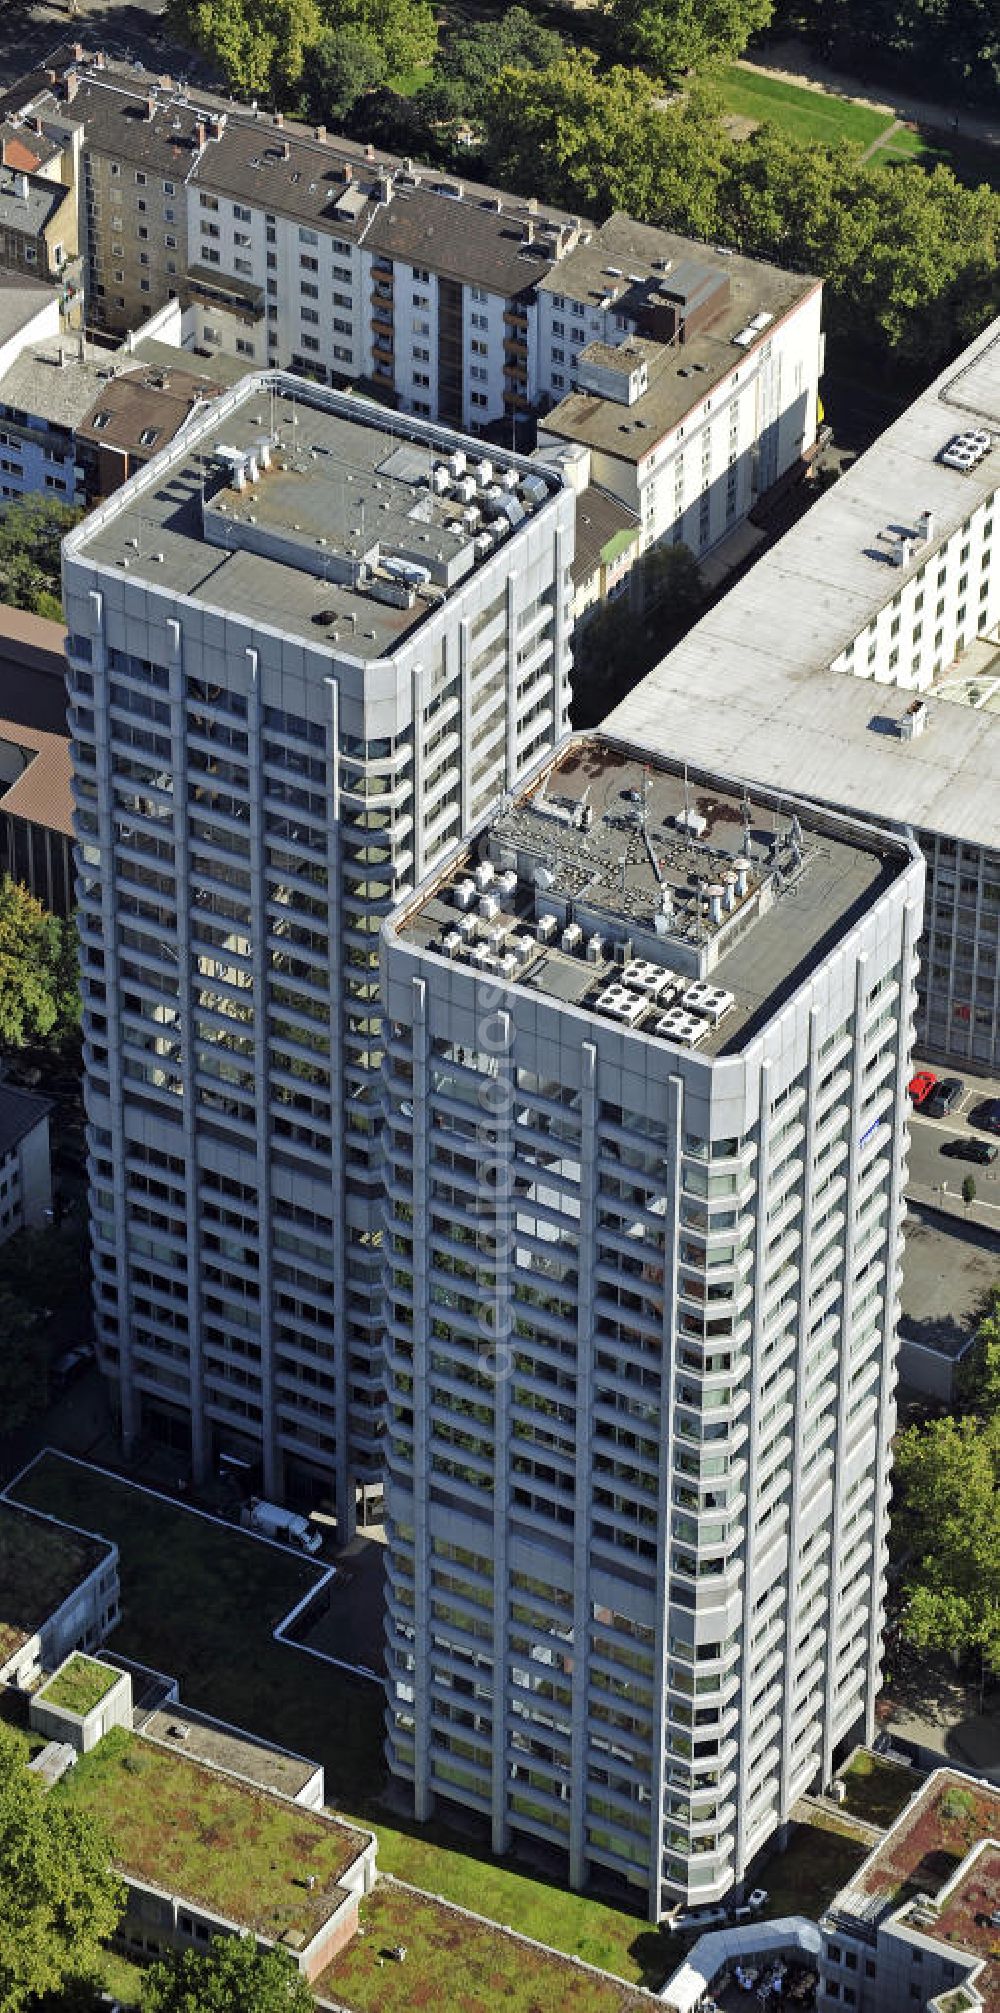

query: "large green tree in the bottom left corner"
left=0, top=1721, right=125, bottom=2013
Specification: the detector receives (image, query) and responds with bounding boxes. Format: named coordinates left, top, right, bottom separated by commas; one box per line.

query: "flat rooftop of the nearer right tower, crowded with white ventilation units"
left=396, top=737, right=905, bottom=1057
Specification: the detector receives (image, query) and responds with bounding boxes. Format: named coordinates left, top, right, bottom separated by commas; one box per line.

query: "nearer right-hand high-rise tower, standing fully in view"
left=382, top=737, right=922, bottom=1916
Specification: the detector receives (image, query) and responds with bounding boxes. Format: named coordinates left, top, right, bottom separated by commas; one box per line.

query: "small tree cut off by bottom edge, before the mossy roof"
left=141, top=1937, right=314, bottom=2013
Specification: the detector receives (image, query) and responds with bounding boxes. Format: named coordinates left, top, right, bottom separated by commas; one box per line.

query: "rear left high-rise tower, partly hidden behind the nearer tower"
left=64, top=374, right=573, bottom=1532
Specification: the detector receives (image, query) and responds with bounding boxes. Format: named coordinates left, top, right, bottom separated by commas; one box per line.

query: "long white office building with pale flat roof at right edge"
left=608, top=322, right=1000, bottom=1071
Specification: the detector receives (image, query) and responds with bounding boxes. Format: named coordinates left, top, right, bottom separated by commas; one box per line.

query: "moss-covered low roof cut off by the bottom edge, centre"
left=316, top=1882, right=648, bottom=2013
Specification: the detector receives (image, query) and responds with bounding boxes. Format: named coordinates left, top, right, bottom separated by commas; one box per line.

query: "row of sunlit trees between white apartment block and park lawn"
left=485, top=50, right=1000, bottom=380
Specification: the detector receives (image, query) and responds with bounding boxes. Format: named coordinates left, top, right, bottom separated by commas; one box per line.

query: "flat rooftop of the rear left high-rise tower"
left=66, top=372, right=561, bottom=660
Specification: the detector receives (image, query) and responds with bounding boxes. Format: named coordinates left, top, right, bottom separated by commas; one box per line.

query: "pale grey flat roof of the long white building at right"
left=606, top=320, right=1000, bottom=845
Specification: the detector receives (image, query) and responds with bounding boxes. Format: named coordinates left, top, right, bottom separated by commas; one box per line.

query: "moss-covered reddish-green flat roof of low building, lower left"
left=58, top=1729, right=368, bottom=1949
